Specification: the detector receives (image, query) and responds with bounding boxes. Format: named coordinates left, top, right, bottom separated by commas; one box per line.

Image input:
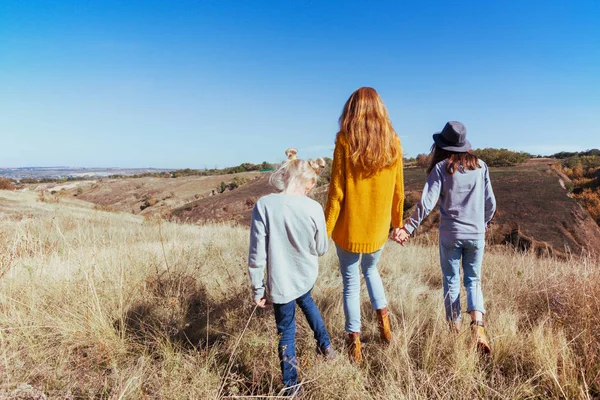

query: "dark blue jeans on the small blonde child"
left=273, top=289, right=331, bottom=386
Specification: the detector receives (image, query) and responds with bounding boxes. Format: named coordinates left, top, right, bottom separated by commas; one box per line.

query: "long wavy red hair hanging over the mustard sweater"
left=338, top=87, right=402, bottom=172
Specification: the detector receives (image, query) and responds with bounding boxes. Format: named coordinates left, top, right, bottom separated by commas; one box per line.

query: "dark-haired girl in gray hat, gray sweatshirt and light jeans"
left=392, top=121, right=496, bottom=354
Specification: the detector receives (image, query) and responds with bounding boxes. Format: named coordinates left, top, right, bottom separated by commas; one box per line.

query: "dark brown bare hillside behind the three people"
left=165, top=158, right=600, bottom=257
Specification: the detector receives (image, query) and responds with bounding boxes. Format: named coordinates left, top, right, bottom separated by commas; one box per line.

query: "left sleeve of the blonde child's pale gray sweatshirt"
left=248, top=203, right=267, bottom=300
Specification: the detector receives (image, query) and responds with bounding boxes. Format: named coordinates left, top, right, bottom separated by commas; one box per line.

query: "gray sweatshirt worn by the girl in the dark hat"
left=404, top=160, right=496, bottom=240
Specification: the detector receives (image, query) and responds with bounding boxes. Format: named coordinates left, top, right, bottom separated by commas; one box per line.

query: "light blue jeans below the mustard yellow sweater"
left=336, top=246, right=387, bottom=332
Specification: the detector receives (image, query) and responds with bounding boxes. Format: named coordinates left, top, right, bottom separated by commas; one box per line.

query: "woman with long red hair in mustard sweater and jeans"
left=325, top=87, right=404, bottom=364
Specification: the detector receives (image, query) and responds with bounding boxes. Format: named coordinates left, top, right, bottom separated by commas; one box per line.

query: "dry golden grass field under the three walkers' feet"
left=0, top=191, right=600, bottom=399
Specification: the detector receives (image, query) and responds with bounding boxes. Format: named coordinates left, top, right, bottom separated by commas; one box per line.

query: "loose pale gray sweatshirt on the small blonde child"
left=248, top=193, right=328, bottom=304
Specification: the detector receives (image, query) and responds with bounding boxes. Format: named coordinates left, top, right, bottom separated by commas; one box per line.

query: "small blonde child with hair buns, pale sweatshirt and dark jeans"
left=248, top=149, right=333, bottom=394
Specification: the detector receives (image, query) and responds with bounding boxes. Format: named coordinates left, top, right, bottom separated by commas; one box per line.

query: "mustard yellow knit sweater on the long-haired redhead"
left=325, top=134, right=404, bottom=253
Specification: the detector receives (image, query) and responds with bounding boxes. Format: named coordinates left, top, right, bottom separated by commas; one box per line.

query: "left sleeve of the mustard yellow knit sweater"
left=325, top=140, right=346, bottom=237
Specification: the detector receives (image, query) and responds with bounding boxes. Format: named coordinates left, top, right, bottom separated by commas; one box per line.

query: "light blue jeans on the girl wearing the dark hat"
left=440, top=238, right=485, bottom=321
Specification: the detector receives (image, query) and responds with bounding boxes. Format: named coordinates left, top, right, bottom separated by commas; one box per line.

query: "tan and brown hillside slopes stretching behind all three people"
left=31, top=158, right=600, bottom=258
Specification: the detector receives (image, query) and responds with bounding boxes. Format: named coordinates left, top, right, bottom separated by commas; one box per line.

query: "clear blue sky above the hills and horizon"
left=0, top=0, right=600, bottom=168
